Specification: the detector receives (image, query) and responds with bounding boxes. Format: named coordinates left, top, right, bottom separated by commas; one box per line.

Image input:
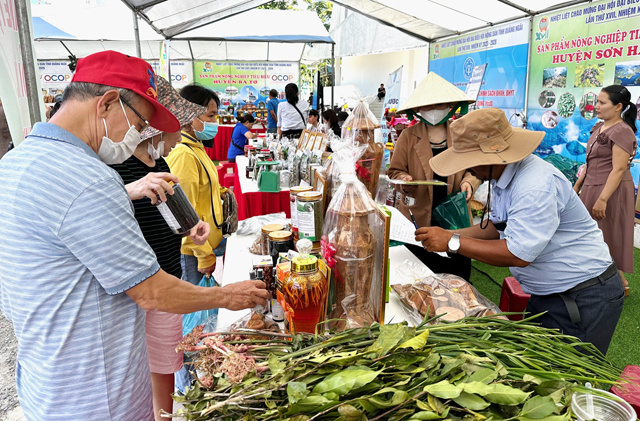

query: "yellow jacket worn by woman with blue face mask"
left=167, top=132, right=227, bottom=269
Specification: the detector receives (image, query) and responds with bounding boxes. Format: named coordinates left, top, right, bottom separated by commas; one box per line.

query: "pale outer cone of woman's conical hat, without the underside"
left=397, top=72, right=476, bottom=113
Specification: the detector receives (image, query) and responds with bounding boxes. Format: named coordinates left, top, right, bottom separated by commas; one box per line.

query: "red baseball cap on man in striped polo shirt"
left=71, top=51, right=180, bottom=133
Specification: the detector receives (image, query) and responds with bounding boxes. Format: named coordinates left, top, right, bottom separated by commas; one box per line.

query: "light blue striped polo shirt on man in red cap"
left=0, top=123, right=159, bottom=421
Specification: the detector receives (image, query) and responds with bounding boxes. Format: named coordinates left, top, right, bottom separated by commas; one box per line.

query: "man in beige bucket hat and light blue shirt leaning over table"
left=416, top=108, right=624, bottom=353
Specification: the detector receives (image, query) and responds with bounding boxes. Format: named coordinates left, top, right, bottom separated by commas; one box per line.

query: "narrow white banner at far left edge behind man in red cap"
left=0, top=1, right=35, bottom=145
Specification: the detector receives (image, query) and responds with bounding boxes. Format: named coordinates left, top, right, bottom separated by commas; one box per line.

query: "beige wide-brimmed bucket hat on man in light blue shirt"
left=429, top=108, right=545, bottom=177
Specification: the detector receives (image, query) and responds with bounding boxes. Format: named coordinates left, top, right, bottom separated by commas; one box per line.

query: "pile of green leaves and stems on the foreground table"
left=174, top=316, right=620, bottom=421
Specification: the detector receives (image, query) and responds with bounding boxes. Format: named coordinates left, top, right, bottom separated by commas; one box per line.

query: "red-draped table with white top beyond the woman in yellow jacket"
left=233, top=156, right=291, bottom=221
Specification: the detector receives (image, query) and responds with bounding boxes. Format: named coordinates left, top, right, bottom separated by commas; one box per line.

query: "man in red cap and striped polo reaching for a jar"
left=0, top=51, right=270, bottom=421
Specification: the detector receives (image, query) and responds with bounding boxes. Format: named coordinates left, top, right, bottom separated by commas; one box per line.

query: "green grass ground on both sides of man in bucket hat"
left=471, top=249, right=640, bottom=368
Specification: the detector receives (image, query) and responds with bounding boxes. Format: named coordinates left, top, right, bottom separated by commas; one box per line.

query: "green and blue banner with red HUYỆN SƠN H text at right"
left=528, top=0, right=640, bottom=185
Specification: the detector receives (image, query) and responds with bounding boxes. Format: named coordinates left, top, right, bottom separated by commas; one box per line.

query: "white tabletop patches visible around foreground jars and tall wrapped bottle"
left=218, top=234, right=432, bottom=328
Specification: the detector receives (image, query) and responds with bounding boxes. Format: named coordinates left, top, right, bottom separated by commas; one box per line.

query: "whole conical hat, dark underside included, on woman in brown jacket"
left=397, top=72, right=476, bottom=126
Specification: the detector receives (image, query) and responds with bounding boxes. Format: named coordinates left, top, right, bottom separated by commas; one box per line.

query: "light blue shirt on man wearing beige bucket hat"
left=490, top=155, right=612, bottom=295
